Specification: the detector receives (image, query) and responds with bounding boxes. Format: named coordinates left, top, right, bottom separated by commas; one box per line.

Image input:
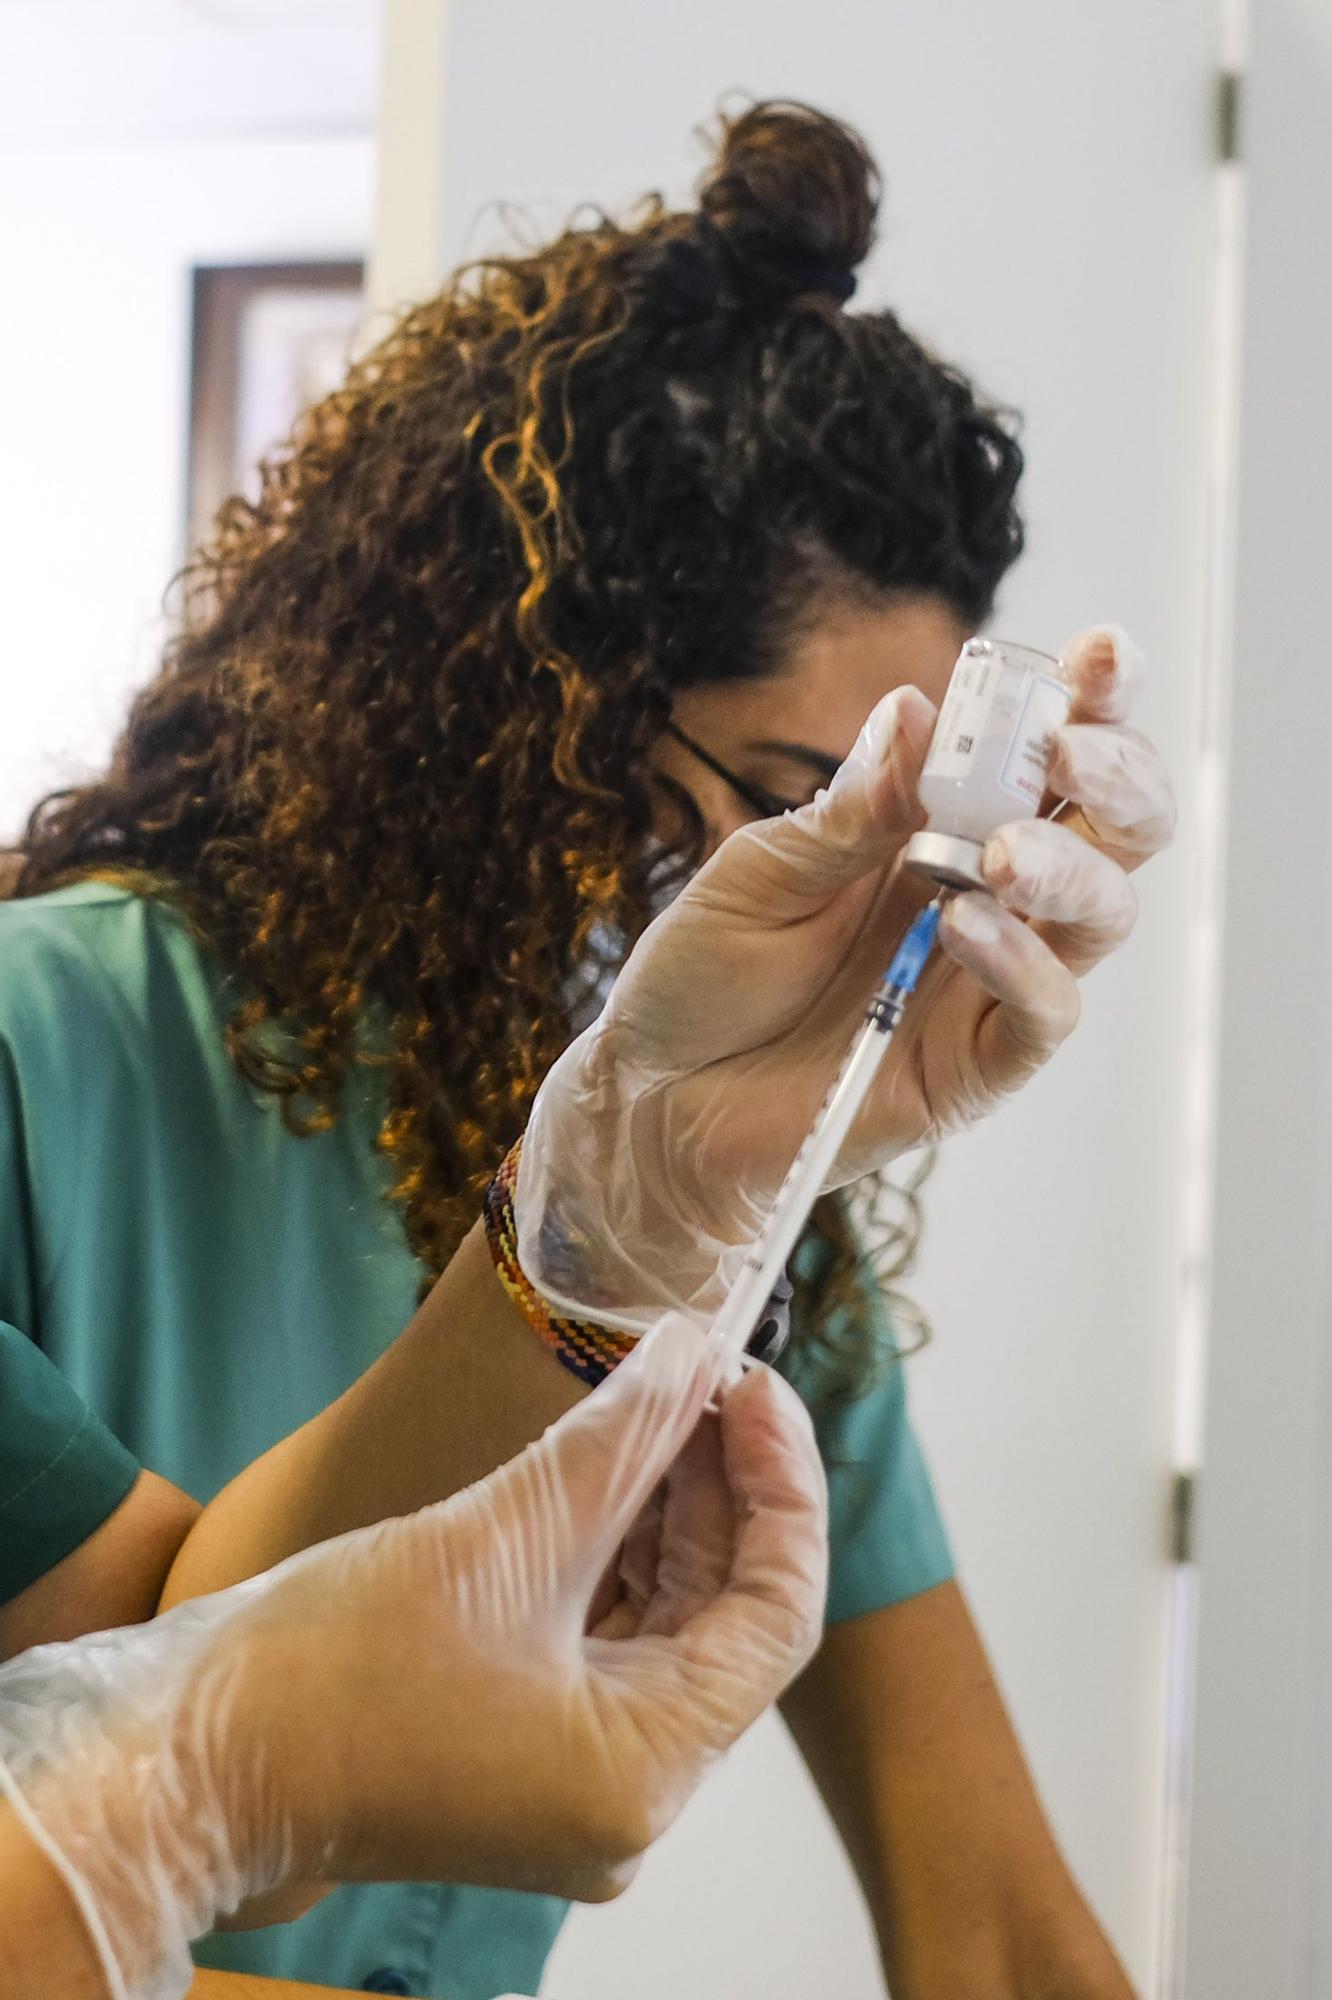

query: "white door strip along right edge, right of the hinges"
left=1182, top=0, right=1332, bottom=2000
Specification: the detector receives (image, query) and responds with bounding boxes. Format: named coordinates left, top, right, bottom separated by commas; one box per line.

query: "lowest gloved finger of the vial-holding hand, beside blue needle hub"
left=938, top=892, right=1080, bottom=1080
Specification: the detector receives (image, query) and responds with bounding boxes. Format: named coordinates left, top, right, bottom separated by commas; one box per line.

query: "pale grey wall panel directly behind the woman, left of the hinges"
left=422, top=0, right=1212, bottom=2000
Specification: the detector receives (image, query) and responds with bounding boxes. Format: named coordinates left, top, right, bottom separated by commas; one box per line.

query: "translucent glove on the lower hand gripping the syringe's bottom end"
left=0, top=1318, right=826, bottom=2000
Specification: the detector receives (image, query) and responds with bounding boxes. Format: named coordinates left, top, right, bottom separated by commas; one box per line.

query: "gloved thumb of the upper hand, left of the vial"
left=692, top=688, right=938, bottom=924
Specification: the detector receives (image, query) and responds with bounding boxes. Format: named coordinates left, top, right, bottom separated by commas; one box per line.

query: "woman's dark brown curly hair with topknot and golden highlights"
left=10, top=104, right=1022, bottom=1386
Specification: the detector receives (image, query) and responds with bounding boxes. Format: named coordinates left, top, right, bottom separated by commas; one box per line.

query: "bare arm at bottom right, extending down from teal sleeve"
left=782, top=1584, right=1132, bottom=2000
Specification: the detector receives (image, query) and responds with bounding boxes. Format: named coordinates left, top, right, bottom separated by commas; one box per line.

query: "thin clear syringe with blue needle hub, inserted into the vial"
left=712, top=894, right=944, bottom=1354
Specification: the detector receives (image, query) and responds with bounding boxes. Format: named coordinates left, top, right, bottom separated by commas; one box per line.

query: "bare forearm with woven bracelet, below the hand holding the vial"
left=162, top=1224, right=582, bottom=1608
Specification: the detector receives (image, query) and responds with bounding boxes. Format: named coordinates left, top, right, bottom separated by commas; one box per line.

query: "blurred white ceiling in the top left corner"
left=0, top=0, right=380, bottom=148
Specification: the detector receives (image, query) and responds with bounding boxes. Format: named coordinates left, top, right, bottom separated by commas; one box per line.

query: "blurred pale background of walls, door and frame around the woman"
left=0, top=0, right=1332, bottom=2000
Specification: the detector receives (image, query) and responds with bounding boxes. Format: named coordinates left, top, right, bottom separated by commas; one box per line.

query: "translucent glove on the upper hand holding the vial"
left=514, top=628, right=1174, bottom=1332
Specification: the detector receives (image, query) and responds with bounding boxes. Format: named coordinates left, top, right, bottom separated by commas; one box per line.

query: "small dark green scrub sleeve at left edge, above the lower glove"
left=0, top=1320, right=138, bottom=1602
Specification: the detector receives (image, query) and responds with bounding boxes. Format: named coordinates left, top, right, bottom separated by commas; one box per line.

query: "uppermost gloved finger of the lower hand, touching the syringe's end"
left=500, top=1312, right=726, bottom=1610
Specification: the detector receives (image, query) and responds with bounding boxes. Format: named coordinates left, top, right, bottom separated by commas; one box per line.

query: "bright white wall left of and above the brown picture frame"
left=0, top=136, right=374, bottom=838
